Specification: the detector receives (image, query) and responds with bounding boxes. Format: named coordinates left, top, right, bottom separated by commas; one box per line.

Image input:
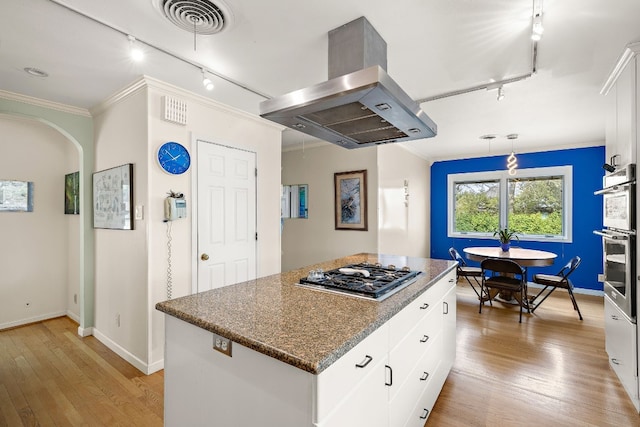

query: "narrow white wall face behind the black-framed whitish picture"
left=93, top=87, right=148, bottom=367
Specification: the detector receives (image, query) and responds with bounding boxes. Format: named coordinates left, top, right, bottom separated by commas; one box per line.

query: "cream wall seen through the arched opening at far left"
left=0, top=116, right=79, bottom=329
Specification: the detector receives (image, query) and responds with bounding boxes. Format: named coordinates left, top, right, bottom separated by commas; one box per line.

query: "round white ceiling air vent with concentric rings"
left=154, top=0, right=233, bottom=35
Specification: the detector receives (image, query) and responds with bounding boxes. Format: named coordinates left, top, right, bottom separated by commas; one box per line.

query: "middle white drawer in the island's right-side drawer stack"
left=389, top=302, right=442, bottom=399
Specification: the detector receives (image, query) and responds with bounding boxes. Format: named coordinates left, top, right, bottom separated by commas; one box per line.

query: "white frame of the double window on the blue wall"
left=447, top=166, right=573, bottom=243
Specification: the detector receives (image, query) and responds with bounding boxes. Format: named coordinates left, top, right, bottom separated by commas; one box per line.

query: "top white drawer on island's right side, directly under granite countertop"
left=389, top=270, right=456, bottom=349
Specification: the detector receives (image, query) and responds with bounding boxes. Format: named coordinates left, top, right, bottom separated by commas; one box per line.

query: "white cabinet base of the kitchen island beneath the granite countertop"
left=165, top=269, right=456, bottom=427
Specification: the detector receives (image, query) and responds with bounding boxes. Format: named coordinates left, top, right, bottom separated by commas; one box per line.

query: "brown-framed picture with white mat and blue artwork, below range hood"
left=334, top=170, right=367, bottom=231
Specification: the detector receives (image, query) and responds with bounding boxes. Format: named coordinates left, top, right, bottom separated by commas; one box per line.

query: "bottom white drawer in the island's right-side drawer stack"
left=389, top=334, right=442, bottom=426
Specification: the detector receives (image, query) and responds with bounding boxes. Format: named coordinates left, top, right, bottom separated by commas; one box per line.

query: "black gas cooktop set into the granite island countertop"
left=300, top=263, right=420, bottom=300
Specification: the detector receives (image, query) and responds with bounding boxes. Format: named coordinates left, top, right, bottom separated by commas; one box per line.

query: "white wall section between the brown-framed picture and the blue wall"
left=378, top=144, right=431, bottom=258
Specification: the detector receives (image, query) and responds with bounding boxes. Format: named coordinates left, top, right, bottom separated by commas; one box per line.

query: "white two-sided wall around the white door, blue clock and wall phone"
left=92, top=77, right=281, bottom=373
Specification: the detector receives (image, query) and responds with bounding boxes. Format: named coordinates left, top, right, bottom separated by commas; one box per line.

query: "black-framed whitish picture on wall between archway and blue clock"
left=93, top=163, right=133, bottom=230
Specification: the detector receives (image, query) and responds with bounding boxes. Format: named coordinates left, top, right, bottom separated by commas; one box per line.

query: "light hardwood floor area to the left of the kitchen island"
left=0, top=317, right=164, bottom=427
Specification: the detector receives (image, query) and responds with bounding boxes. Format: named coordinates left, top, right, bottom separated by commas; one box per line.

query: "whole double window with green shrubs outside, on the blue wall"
left=448, top=166, right=572, bottom=242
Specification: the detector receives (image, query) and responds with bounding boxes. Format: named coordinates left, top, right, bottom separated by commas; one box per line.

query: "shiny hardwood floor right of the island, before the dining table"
left=426, top=282, right=640, bottom=427
